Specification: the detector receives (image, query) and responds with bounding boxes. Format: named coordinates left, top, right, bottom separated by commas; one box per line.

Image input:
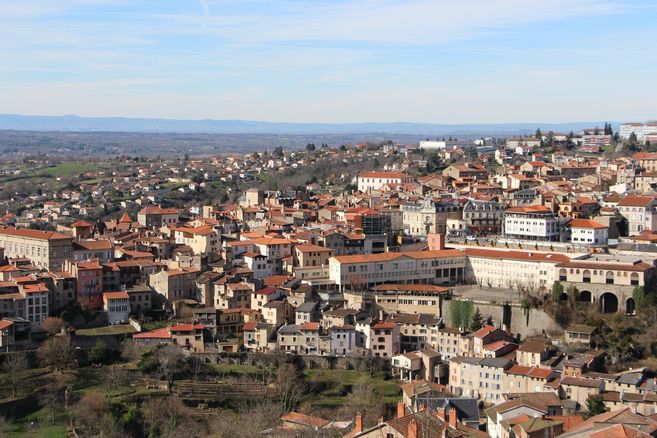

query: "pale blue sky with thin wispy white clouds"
left=0, top=0, right=657, bottom=123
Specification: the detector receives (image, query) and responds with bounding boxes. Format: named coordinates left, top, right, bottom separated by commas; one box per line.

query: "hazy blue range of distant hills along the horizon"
left=0, top=114, right=617, bottom=137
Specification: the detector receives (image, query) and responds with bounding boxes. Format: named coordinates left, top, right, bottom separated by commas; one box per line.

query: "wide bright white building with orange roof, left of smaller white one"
left=504, top=205, right=559, bottom=241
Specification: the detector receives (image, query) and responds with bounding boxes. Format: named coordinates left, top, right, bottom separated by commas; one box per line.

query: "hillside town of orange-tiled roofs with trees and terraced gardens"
left=0, top=122, right=657, bottom=438
